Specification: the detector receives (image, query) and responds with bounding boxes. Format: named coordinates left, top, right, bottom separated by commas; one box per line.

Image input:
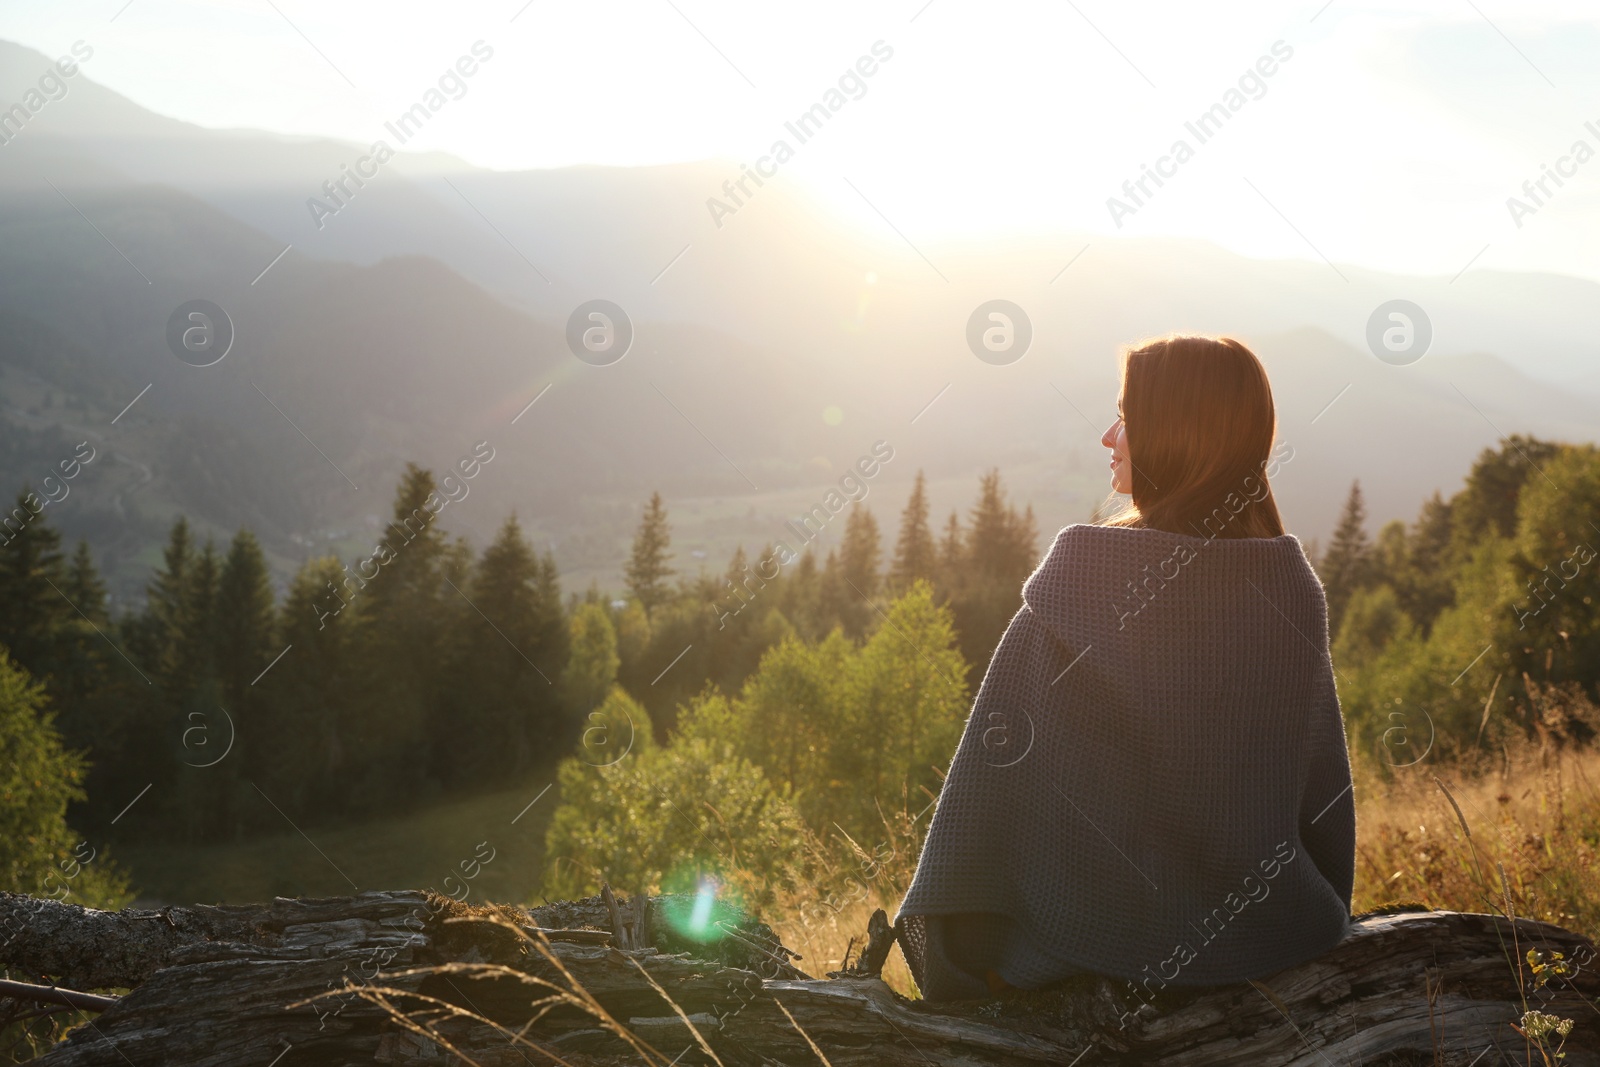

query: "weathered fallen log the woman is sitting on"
left=0, top=891, right=1600, bottom=1067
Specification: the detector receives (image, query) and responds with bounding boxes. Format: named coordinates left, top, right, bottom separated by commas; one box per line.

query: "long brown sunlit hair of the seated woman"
left=1106, top=336, right=1283, bottom=537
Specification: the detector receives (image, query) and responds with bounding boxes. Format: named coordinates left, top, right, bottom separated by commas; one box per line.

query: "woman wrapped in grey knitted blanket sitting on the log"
left=898, top=336, right=1355, bottom=1000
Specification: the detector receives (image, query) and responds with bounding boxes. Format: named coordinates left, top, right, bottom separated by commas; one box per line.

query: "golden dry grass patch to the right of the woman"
left=1352, top=742, right=1600, bottom=937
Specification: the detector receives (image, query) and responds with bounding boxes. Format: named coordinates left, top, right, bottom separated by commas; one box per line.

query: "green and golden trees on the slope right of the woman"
left=1320, top=438, right=1600, bottom=773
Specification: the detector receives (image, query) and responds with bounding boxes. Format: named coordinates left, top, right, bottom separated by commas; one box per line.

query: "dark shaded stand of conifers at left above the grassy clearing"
left=0, top=466, right=576, bottom=841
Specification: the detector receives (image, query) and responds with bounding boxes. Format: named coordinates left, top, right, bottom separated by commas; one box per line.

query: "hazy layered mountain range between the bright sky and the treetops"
left=0, top=43, right=1600, bottom=597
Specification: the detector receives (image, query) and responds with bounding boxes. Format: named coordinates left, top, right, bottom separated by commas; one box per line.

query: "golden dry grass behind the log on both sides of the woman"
left=748, top=726, right=1600, bottom=997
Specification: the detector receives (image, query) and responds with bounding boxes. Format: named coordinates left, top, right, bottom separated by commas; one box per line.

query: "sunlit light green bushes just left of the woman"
left=546, top=581, right=968, bottom=923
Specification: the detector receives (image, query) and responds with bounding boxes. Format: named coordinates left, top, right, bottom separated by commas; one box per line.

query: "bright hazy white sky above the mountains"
left=9, top=0, right=1600, bottom=278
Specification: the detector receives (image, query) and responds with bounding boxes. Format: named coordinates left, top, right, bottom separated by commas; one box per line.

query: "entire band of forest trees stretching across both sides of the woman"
left=12, top=428, right=1600, bottom=921
